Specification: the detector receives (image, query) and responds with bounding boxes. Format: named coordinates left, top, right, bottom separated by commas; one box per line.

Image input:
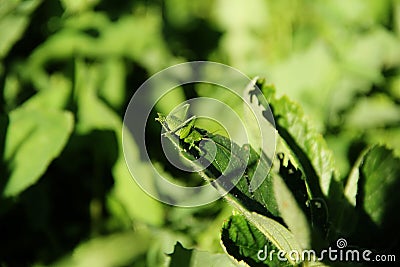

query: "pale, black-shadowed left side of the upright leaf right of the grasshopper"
left=271, top=140, right=328, bottom=248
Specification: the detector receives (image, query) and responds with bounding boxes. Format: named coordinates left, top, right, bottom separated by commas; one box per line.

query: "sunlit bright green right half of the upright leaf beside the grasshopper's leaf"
left=261, top=86, right=335, bottom=198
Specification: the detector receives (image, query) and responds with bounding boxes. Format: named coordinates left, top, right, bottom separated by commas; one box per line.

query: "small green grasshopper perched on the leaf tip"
left=156, top=104, right=204, bottom=152
